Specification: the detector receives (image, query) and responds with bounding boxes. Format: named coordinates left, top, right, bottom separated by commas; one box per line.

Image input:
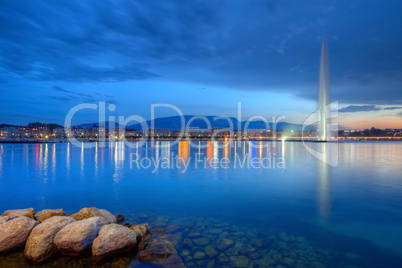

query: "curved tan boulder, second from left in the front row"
left=24, top=216, right=75, bottom=262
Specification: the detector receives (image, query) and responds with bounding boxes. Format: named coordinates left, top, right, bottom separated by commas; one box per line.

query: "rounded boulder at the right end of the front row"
left=92, top=224, right=137, bottom=260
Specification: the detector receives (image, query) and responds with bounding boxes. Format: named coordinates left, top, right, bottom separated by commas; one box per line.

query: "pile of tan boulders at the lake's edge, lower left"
left=0, top=207, right=185, bottom=267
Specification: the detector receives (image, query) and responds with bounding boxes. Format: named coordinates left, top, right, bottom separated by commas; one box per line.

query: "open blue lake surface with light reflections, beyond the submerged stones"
left=0, top=141, right=402, bottom=266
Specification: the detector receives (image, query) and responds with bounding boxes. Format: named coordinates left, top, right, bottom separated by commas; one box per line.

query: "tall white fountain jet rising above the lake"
left=318, top=38, right=329, bottom=141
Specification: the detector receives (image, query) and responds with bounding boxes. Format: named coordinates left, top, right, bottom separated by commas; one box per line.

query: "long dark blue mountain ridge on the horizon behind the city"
left=79, top=115, right=316, bottom=131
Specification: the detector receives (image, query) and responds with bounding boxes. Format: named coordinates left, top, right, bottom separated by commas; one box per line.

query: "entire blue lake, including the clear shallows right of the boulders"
left=0, top=142, right=402, bottom=267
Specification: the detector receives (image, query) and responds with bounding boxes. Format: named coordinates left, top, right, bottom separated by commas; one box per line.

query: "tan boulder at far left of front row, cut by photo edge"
left=0, top=216, right=38, bottom=253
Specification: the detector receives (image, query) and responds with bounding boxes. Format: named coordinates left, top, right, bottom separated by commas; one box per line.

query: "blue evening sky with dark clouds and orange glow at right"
left=0, top=0, right=402, bottom=128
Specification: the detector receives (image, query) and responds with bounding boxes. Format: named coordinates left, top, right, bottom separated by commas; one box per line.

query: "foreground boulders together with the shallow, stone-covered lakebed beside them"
left=0, top=208, right=374, bottom=268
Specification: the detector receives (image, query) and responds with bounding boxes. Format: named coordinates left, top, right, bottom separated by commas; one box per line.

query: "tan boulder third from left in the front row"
left=54, top=217, right=106, bottom=256
